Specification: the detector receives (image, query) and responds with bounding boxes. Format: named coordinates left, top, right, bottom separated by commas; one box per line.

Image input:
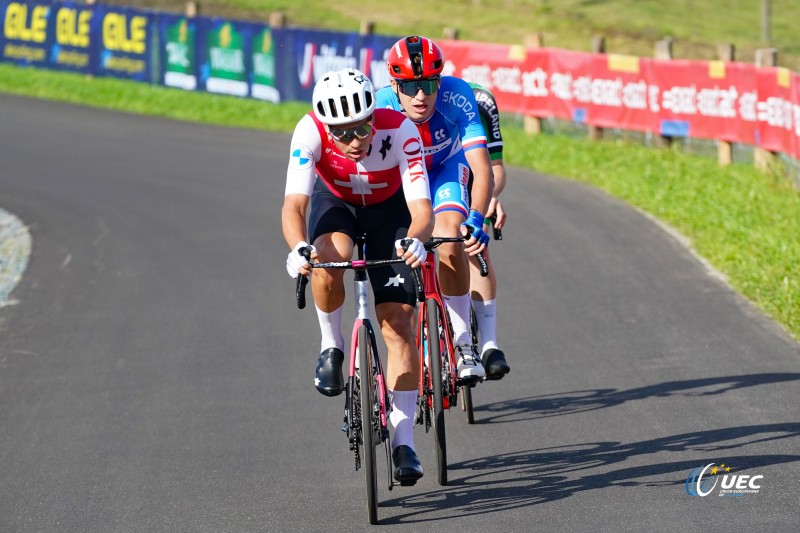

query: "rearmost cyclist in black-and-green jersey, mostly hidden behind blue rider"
left=469, top=82, right=511, bottom=379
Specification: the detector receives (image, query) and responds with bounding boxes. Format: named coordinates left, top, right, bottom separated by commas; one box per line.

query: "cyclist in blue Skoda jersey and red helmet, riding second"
left=377, top=35, right=492, bottom=381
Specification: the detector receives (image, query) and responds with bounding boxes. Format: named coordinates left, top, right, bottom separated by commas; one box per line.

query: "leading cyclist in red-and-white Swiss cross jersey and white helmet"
left=281, top=68, right=434, bottom=484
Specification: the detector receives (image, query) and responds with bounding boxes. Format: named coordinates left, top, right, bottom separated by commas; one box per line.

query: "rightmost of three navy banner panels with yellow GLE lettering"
left=91, top=5, right=158, bottom=83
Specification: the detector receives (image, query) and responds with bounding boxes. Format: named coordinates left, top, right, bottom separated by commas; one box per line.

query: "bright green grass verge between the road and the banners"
left=0, top=64, right=800, bottom=337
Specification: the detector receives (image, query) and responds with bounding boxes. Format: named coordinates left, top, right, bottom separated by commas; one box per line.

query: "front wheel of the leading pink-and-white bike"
left=357, top=325, right=378, bottom=525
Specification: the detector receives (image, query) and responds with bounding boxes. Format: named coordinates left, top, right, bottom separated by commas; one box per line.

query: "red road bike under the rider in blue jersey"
left=417, top=237, right=488, bottom=486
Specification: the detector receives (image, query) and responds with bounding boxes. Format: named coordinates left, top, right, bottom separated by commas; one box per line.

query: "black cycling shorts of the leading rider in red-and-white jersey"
left=308, top=179, right=417, bottom=306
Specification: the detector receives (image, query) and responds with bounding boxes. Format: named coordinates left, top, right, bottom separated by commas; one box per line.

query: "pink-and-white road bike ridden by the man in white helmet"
left=295, top=236, right=420, bottom=524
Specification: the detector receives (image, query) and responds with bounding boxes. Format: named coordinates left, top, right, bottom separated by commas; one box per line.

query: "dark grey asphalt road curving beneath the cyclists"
left=0, top=95, right=800, bottom=533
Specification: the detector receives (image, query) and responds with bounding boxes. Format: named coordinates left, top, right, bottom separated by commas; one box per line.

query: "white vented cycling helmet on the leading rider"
left=311, top=68, right=375, bottom=126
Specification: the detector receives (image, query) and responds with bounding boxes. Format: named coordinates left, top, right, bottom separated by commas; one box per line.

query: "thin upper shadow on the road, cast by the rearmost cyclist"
left=475, top=373, right=800, bottom=424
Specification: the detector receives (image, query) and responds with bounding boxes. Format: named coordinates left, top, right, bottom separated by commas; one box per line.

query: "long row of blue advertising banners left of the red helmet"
left=0, top=0, right=397, bottom=103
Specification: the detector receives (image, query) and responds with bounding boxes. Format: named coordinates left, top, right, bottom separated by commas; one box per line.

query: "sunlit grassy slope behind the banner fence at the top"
left=112, top=0, right=800, bottom=70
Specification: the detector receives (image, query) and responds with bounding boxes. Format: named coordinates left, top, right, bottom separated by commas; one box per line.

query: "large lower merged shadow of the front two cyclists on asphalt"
left=381, top=423, right=800, bottom=524
